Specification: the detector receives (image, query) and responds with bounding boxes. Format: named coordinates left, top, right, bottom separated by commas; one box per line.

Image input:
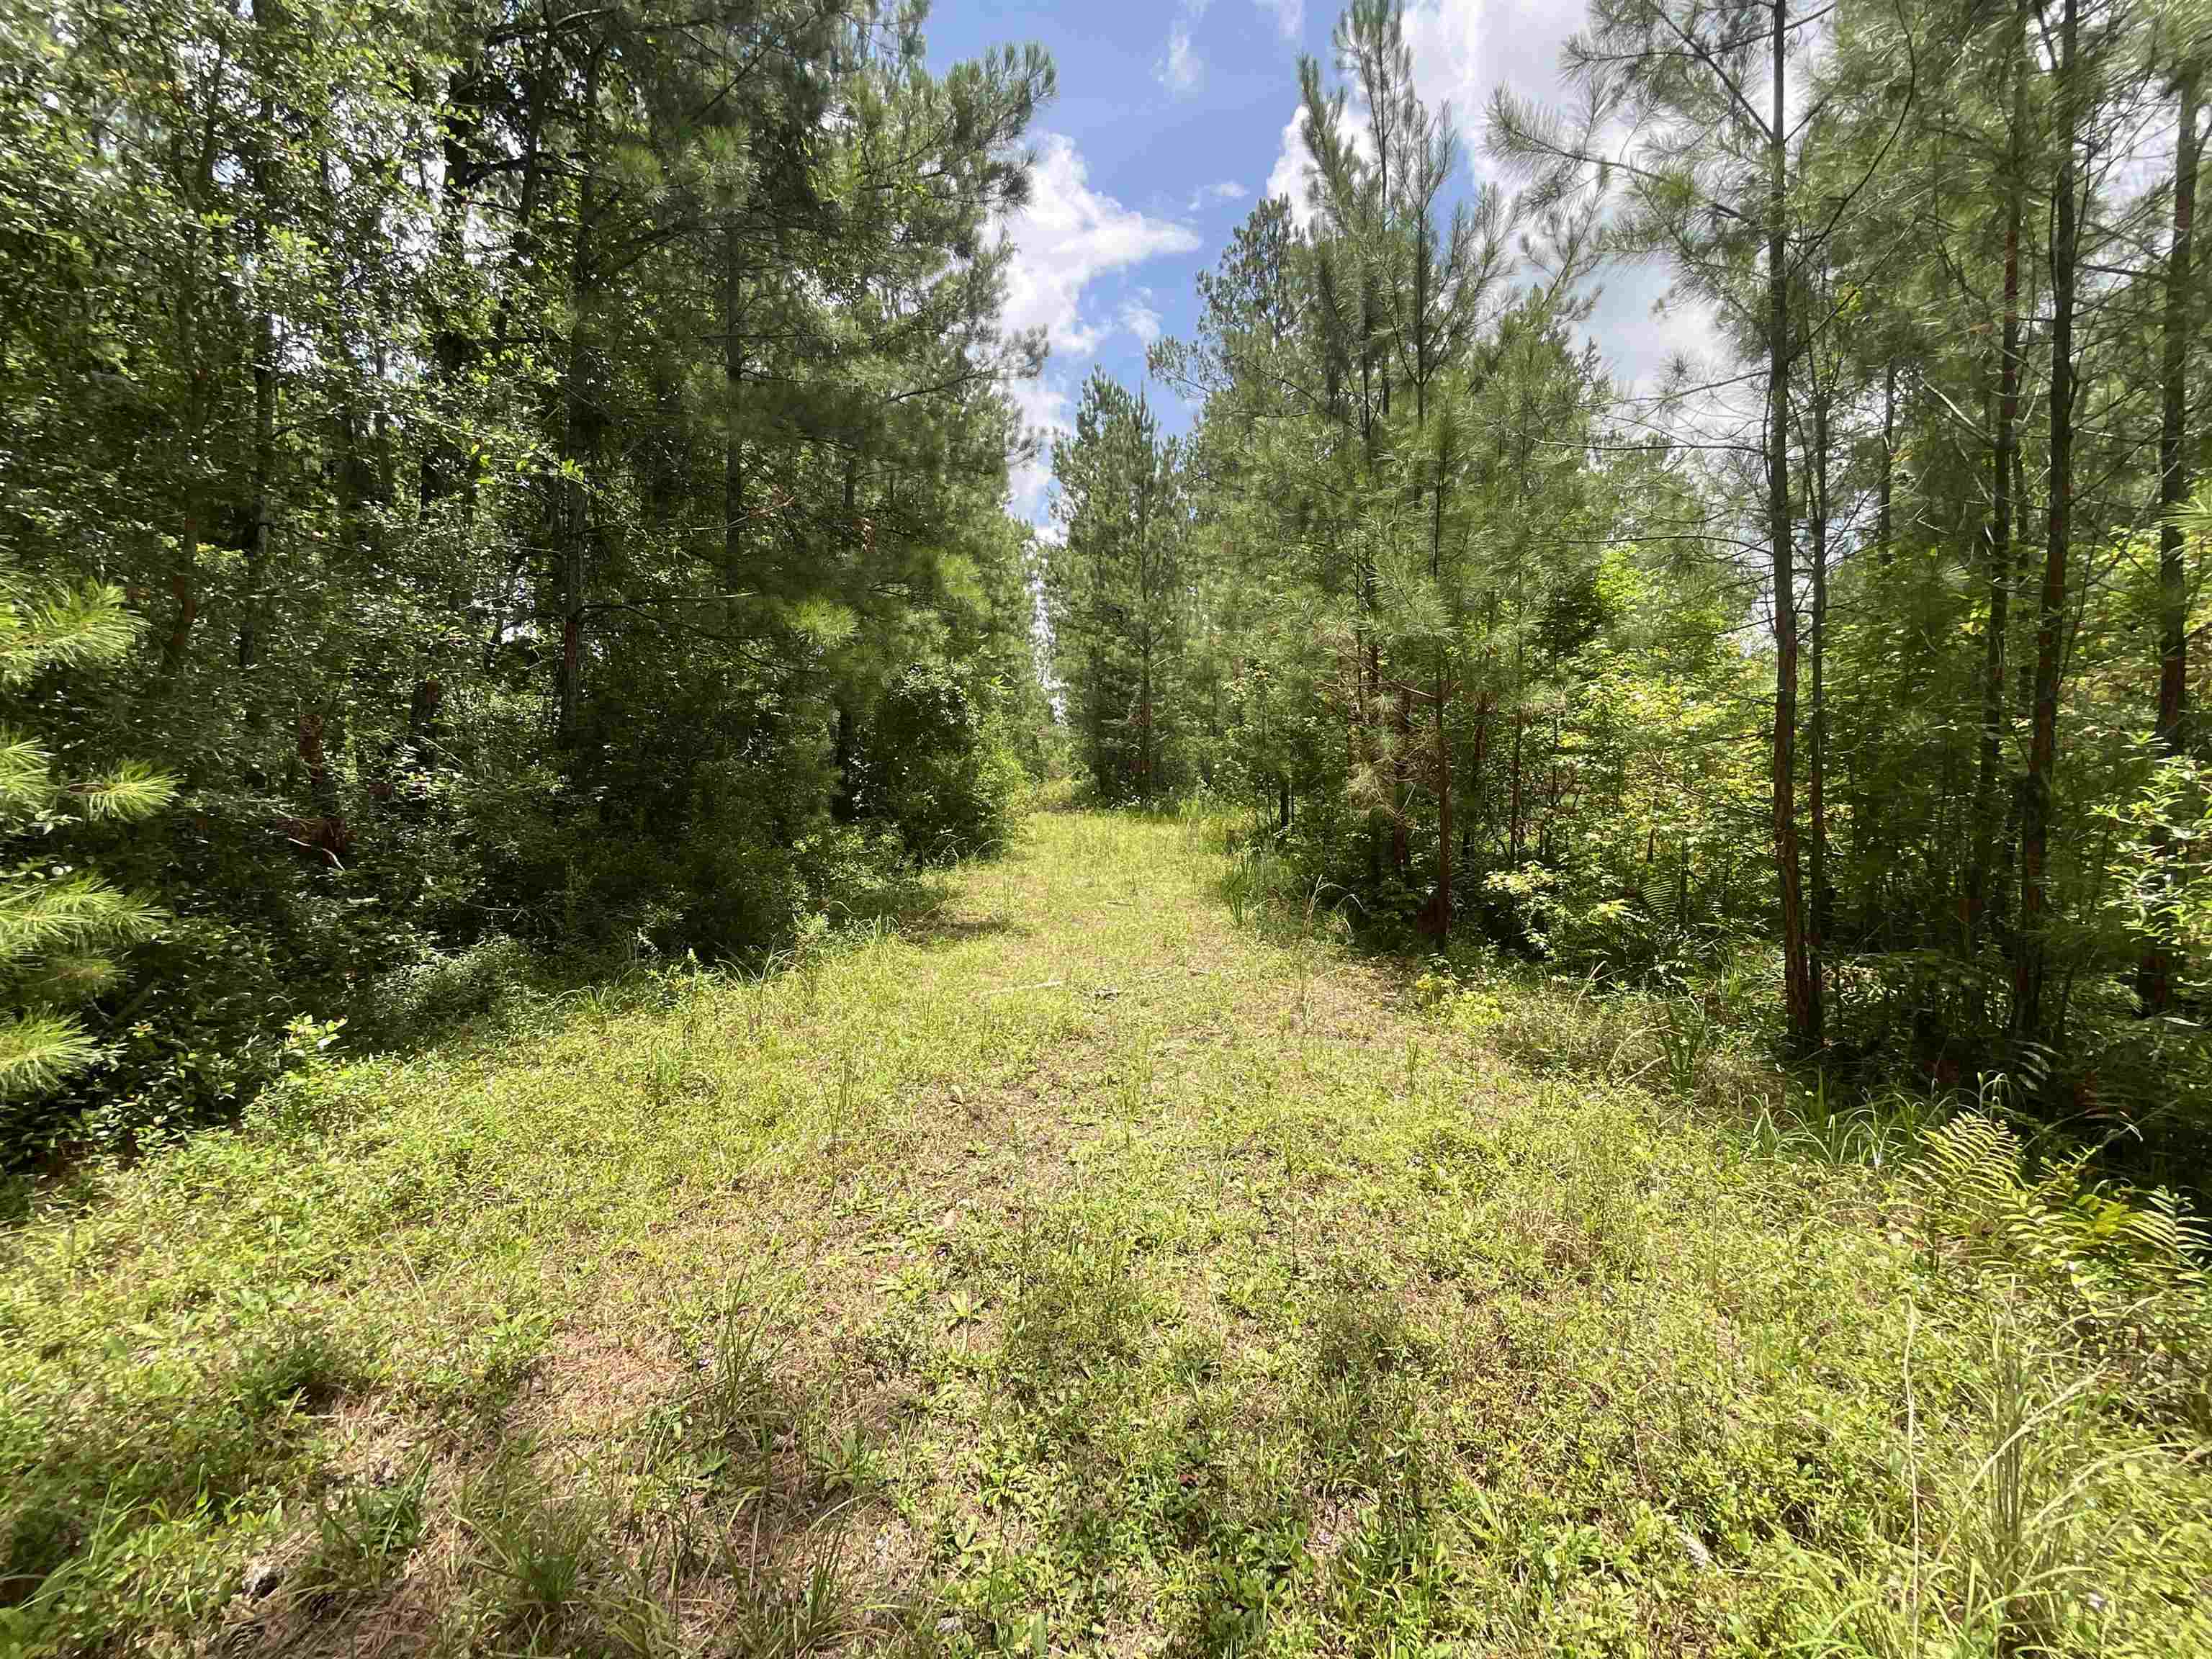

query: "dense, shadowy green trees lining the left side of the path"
left=0, top=0, right=1053, bottom=1159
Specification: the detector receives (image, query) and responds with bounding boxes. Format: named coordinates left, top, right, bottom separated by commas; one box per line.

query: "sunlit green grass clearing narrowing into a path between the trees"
left=0, top=814, right=2212, bottom=1657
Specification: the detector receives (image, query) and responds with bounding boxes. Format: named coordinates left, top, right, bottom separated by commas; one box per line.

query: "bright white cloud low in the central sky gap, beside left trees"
left=1004, top=132, right=1199, bottom=522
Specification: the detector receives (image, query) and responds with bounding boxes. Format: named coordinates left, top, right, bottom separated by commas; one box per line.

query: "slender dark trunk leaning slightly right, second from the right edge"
left=2013, top=0, right=2082, bottom=1042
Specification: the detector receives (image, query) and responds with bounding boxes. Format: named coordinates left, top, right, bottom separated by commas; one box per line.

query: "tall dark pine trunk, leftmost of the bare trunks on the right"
left=1768, top=0, right=1818, bottom=1053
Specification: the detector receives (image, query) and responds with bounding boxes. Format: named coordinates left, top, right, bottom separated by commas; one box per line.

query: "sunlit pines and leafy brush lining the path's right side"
left=1044, top=0, right=2212, bottom=1179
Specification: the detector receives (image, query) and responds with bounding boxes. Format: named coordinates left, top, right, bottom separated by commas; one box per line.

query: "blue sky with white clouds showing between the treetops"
left=929, top=0, right=1701, bottom=522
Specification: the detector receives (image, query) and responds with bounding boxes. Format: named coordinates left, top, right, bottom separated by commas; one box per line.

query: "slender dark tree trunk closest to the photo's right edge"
left=2139, top=62, right=2201, bottom=1013
